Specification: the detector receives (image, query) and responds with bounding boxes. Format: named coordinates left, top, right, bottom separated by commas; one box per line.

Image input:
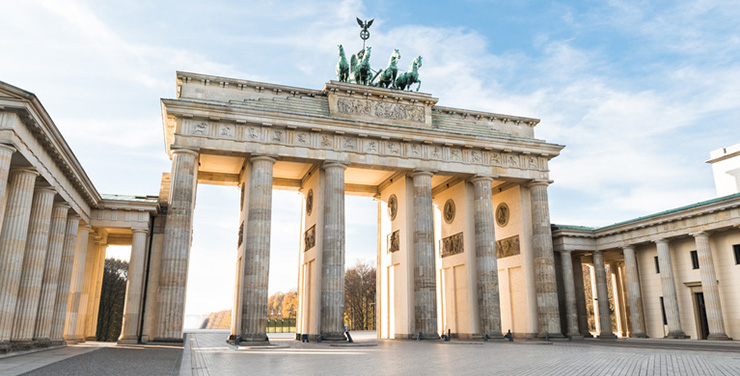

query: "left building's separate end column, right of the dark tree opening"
left=118, top=229, right=148, bottom=343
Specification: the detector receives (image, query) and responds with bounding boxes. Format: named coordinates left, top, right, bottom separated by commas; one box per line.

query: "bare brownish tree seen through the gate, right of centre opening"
left=344, top=260, right=376, bottom=330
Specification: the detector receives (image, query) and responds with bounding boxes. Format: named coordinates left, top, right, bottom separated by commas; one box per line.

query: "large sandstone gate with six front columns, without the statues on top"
left=147, top=71, right=563, bottom=343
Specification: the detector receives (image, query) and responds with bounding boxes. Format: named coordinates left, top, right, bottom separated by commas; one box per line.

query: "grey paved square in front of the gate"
left=0, top=330, right=740, bottom=376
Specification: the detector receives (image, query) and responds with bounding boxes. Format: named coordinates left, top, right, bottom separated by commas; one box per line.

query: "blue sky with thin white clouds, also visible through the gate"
left=0, top=0, right=740, bottom=315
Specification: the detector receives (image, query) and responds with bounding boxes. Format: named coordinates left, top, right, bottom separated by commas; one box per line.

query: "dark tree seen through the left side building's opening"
left=96, top=259, right=128, bottom=342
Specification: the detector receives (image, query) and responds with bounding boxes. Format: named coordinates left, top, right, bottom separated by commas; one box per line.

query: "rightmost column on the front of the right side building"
left=692, top=231, right=732, bottom=340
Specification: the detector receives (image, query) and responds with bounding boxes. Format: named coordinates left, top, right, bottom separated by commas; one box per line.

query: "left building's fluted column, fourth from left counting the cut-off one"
left=33, top=202, right=69, bottom=347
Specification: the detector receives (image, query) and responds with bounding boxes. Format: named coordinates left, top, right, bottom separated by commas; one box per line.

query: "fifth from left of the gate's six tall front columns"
left=471, top=176, right=503, bottom=338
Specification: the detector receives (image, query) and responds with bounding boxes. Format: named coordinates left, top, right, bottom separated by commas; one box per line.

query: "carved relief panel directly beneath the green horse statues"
left=337, top=97, right=425, bottom=123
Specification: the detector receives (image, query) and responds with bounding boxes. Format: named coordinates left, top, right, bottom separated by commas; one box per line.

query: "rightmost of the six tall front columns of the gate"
left=529, top=181, right=563, bottom=337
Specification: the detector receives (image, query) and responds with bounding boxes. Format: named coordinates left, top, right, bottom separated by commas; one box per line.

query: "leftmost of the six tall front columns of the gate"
left=154, top=149, right=198, bottom=342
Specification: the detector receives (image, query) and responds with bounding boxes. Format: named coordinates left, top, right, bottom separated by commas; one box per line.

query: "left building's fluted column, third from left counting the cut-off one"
left=10, top=187, right=56, bottom=349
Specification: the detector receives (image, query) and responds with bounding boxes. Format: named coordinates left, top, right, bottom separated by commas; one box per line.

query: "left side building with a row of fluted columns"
left=0, top=82, right=159, bottom=352
